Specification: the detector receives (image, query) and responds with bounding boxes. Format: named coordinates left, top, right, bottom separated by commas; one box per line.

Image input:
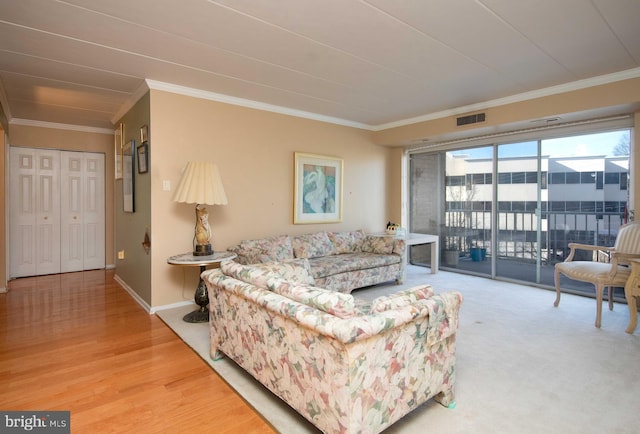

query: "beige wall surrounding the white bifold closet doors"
left=3, top=125, right=114, bottom=268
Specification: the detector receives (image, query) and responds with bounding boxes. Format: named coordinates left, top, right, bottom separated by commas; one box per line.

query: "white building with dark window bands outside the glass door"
left=443, top=153, right=629, bottom=262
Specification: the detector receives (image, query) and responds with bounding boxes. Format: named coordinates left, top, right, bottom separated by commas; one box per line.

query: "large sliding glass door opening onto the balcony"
left=410, top=129, right=630, bottom=290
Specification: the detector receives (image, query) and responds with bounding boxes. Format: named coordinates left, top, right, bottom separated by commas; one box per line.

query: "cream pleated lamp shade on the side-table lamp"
left=173, top=161, right=227, bottom=205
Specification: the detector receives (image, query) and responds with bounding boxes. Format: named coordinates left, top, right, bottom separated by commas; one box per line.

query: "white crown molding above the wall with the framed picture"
left=145, top=79, right=374, bottom=130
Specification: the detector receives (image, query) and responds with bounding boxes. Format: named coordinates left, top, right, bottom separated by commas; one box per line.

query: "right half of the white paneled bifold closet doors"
left=60, top=151, right=105, bottom=273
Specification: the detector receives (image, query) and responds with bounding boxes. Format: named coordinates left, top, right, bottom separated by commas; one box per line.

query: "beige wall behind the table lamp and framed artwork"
left=150, top=90, right=400, bottom=306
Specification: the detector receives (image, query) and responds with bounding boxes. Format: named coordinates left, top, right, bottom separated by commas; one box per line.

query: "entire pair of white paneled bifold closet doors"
left=9, top=147, right=105, bottom=278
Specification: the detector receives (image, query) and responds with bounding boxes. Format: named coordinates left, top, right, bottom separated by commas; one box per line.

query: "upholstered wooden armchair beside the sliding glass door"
left=553, top=222, right=640, bottom=327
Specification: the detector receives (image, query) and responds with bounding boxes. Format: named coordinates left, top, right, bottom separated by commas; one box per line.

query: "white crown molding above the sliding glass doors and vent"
left=372, top=68, right=640, bottom=131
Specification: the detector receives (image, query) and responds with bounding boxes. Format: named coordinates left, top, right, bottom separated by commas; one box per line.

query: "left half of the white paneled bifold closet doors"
left=9, top=147, right=60, bottom=277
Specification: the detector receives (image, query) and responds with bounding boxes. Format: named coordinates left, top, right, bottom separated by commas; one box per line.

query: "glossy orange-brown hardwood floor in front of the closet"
left=0, top=270, right=275, bottom=433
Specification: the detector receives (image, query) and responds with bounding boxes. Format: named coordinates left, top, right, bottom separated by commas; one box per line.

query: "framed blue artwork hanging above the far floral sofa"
left=293, top=152, right=343, bottom=224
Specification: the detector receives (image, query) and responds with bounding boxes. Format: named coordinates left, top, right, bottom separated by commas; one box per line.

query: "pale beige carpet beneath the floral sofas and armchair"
left=157, top=266, right=640, bottom=434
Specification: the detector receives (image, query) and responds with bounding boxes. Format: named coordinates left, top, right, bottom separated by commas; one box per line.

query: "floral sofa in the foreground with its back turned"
left=202, top=258, right=462, bottom=433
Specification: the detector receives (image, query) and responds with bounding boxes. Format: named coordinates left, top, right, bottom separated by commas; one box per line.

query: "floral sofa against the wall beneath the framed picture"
left=228, top=230, right=406, bottom=293
